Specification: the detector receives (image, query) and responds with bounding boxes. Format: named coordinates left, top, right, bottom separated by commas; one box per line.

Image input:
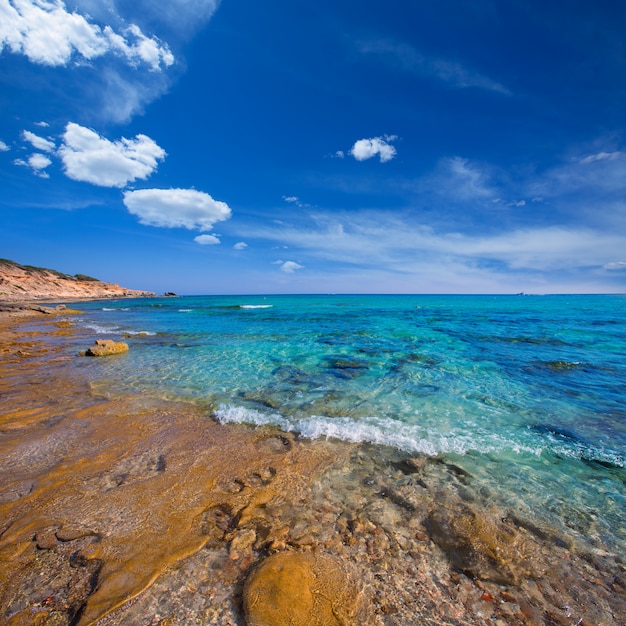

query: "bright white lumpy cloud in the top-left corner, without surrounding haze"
left=0, top=0, right=174, bottom=70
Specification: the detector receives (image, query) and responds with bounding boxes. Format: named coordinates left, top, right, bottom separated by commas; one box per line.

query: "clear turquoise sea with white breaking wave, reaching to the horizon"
left=70, top=295, right=626, bottom=554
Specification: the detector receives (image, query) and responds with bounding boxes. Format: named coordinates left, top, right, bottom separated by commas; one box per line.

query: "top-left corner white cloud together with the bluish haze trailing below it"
left=0, top=0, right=219, bottom=124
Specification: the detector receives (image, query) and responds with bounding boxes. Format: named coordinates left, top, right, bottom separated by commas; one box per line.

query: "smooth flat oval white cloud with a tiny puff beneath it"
left=124, top=189, right=232, bottom=233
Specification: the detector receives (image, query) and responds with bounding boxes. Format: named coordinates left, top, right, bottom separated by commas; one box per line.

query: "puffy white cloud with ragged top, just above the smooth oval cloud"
left=59, top=122, right=166, bottom=187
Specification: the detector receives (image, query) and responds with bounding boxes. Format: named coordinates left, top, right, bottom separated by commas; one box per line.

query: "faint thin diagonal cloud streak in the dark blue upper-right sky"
left=358, top=39, right=511, bottom=95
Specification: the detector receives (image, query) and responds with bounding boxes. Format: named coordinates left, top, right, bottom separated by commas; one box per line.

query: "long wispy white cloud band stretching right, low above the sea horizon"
left=240, top=211, right=626, bottom=272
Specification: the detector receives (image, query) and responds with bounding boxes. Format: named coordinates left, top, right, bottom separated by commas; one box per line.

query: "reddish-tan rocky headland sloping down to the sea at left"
left=0, top=259, right=155, bottom=308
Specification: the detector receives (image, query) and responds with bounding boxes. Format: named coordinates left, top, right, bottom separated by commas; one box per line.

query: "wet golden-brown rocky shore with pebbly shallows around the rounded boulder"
left=0, top=316, right=626, bottom=626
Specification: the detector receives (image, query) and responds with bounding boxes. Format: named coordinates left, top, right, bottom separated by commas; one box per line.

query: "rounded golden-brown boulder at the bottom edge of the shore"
left=243, top=552, right=368, bottom=626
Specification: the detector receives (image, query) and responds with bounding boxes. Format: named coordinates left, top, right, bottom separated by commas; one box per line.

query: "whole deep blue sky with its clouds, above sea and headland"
left=0, top=0, right=626, bottom=294
